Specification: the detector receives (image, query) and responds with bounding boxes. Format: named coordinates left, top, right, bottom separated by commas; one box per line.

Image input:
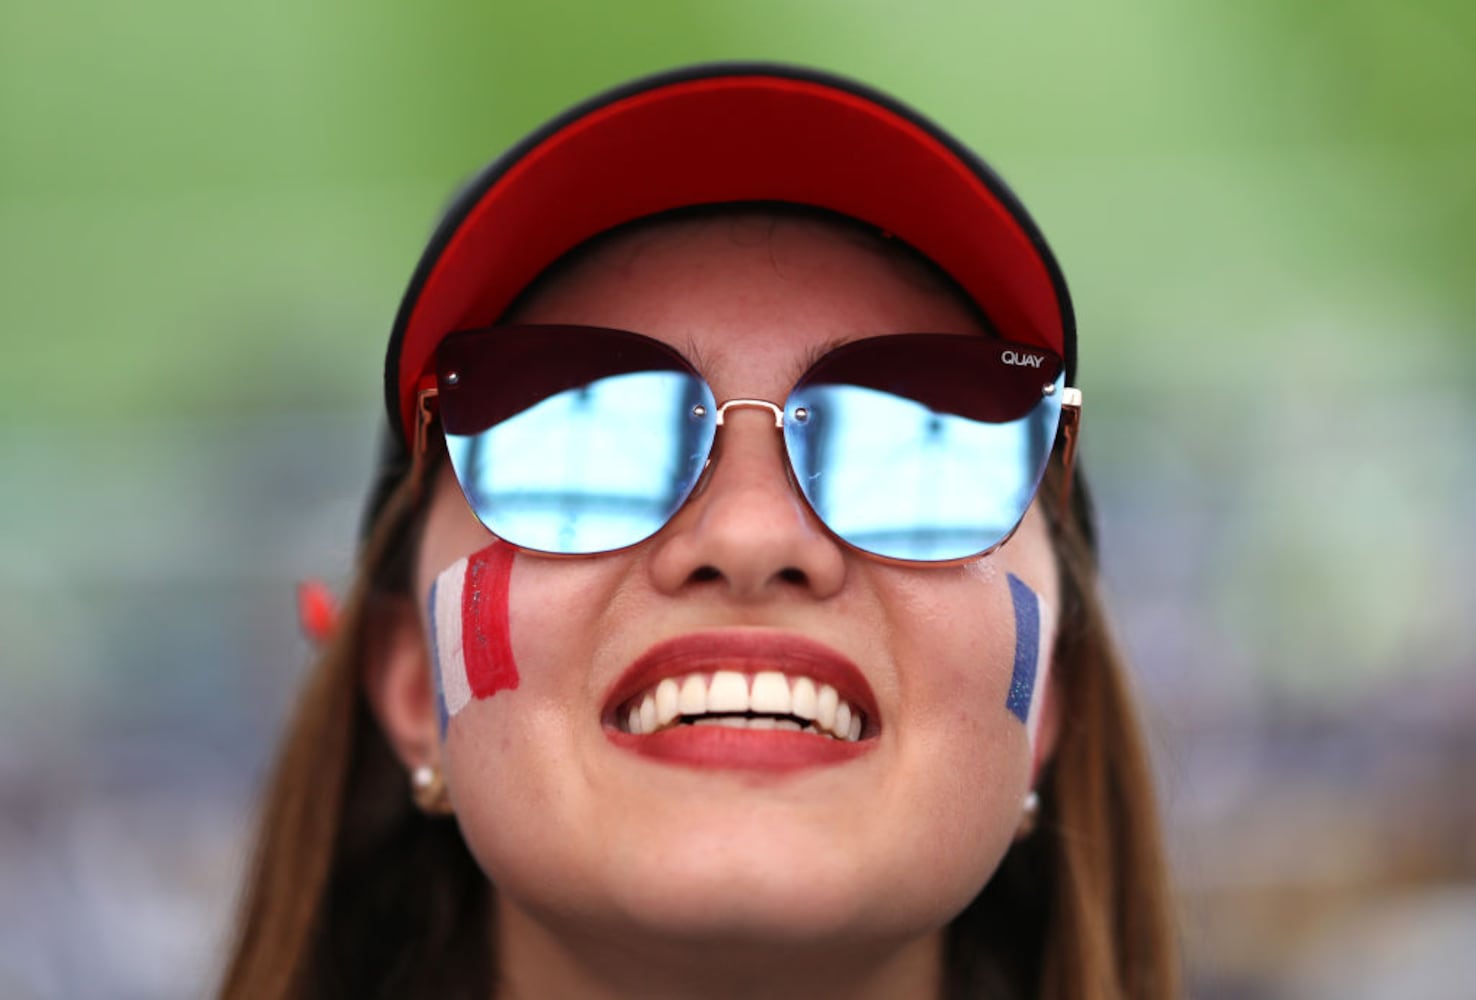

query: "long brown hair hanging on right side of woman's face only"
left=949, top=451, right=1179, bottom=1000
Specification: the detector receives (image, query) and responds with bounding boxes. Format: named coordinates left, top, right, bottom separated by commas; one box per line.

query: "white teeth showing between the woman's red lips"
left=615, top=670, right=865, bottom=742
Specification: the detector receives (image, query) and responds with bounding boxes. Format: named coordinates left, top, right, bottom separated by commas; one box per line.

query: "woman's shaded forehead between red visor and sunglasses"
left=508, top=211, right=984, bottom=392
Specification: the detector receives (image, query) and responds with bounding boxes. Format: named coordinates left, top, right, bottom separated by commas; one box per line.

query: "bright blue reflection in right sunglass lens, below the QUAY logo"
left=784, top=378, right=1061, bottom=560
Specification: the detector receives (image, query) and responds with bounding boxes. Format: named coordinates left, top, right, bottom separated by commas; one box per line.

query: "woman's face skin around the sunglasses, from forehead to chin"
left=416, top=215, right=1058, bottom=942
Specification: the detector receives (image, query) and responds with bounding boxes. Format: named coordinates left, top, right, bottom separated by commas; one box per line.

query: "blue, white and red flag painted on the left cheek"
left=428, top=541, right=518, bottom=739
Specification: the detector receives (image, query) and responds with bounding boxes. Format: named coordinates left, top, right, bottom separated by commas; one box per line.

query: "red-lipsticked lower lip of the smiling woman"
left=605, top=726, right=875, bottom=771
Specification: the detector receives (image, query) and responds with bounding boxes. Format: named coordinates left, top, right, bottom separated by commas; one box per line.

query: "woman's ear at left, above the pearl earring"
left=363, top=597, right=440, bottom=770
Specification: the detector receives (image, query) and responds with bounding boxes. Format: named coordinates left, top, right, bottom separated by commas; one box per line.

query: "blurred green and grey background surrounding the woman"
left=0, top=0, right=1476, bottom=1000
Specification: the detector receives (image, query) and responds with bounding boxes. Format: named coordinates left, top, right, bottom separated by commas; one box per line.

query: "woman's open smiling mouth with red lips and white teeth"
left=604, top=630, right=880, bottom=768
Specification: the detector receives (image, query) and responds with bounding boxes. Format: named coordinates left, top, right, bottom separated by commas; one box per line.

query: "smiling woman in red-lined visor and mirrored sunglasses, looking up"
left=223, top=66, right=1176, bottom=997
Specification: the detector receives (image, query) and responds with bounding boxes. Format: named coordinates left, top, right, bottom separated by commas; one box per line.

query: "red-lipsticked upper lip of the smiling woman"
left=602, top=628, right=881, bottom=730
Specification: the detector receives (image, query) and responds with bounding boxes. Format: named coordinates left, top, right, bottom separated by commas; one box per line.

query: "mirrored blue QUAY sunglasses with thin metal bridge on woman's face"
left=416, top=326, right=1080, bottom=563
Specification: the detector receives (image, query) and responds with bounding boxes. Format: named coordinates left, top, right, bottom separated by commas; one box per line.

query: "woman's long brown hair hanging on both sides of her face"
left=220, top=448, right=1178, bottom=1000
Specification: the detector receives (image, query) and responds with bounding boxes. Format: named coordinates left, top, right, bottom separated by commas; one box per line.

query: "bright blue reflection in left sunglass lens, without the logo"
left=446, top=370, right=716, bottom=553
